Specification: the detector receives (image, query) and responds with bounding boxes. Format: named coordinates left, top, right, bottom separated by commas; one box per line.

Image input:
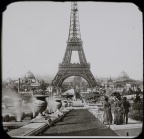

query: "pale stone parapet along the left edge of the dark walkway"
left=3, top=108, right=72, bottom=137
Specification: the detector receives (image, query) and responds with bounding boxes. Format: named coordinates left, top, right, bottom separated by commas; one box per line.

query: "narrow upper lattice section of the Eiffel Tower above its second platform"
left=68, top=2, right=81, bottom=42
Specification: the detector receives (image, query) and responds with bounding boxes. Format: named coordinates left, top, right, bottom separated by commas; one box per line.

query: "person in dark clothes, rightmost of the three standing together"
left=123, top=97, right=130, bottom=124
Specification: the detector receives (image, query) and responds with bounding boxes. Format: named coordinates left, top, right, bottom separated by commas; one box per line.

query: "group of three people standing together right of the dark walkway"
left=103, top=96, right=140, bottom=125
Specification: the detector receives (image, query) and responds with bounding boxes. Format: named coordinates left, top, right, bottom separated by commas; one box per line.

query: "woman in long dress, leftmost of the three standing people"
left=103, top=97, right=112, bottom=124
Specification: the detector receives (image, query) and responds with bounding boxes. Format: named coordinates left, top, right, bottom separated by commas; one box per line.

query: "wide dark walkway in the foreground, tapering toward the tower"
left=41, top=109, right=118, bottom=136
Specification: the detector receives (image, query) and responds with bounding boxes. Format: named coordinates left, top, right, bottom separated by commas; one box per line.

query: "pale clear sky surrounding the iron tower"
left=2, top=2, right=143, bottom=80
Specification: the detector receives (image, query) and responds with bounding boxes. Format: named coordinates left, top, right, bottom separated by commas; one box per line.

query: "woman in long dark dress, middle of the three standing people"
left=114, top=96, right=123, bottom=125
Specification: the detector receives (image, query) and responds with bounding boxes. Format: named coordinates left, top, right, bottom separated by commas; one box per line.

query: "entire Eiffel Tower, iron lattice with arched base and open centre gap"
left=52, top=2, right=97, bottom=87
